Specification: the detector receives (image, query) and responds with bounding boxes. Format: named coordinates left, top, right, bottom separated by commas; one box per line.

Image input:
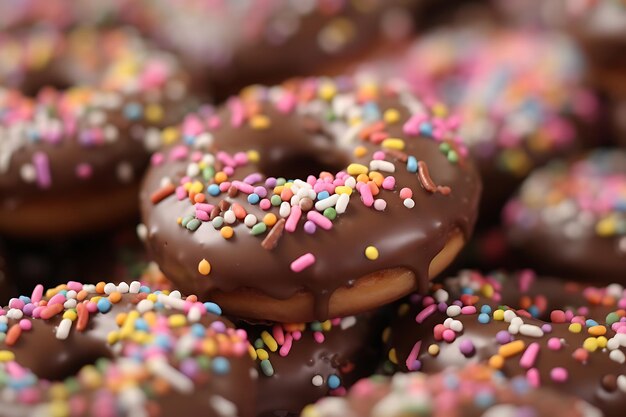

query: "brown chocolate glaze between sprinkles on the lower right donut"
left=382, top=272, right=626, bottom=417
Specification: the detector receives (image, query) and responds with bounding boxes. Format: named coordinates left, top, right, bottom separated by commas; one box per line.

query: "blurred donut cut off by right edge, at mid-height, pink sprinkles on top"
left=503, top=148, right=626, bottom=283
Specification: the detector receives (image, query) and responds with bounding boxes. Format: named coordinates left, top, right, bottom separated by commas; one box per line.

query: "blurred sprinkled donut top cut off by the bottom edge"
left=302, top=365, right=602, bottom=417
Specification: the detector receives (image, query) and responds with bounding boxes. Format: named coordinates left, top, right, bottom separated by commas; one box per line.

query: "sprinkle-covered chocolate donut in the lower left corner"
left=0, top=281, right=256, bottom=417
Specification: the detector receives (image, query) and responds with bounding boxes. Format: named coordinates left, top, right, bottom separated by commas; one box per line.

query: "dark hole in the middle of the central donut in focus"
left=260, top=151, right=349, bottom=180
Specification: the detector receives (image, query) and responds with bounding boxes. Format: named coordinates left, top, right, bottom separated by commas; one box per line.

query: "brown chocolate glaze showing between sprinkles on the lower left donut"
left=0, top=286, right=256, bottom=417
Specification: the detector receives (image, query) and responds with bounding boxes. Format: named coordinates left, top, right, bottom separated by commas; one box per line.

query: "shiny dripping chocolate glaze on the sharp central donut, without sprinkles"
left=140, top=79, right=481, bottom=320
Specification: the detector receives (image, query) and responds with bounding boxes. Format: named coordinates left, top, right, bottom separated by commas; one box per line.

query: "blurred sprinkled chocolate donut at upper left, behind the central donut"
left=0, top=28, right=187, bottom=239
